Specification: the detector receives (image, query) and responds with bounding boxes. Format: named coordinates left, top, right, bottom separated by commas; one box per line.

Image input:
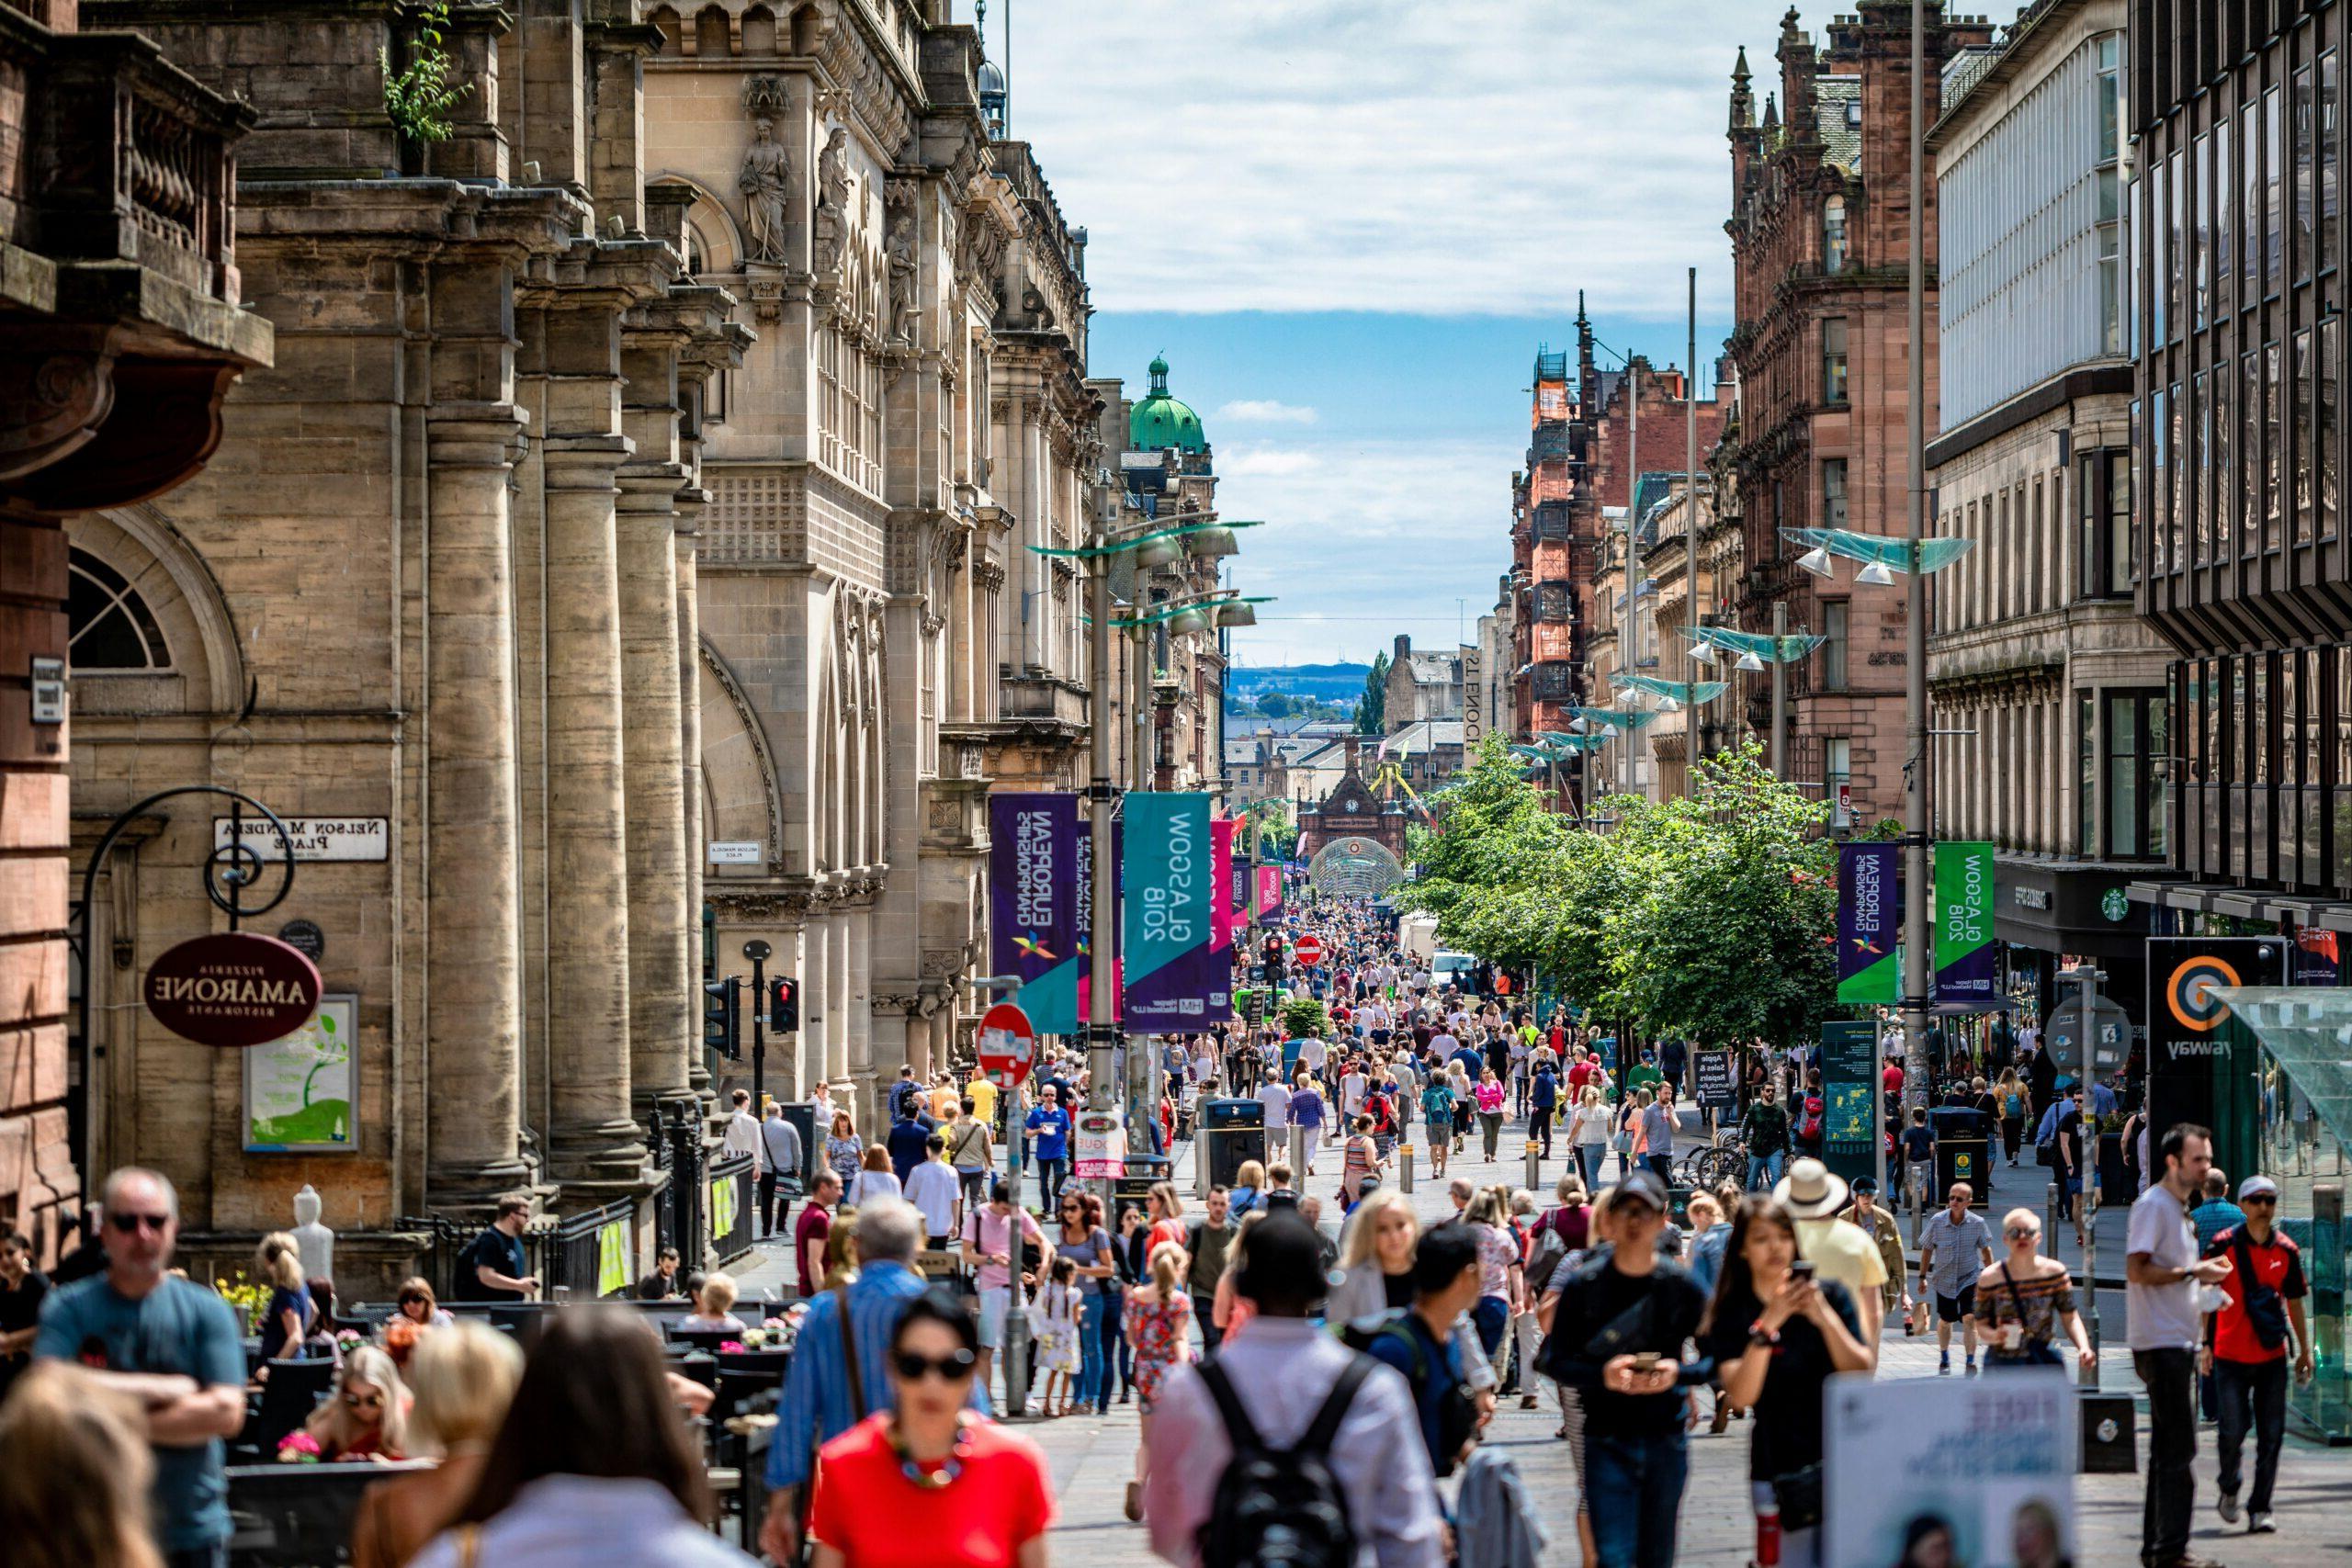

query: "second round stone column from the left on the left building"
left=543, top=434, right=644, bottom=1187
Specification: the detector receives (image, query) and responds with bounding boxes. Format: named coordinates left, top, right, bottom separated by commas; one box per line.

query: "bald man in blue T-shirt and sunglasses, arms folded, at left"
left=33, top=1166, right=244, bottom=1568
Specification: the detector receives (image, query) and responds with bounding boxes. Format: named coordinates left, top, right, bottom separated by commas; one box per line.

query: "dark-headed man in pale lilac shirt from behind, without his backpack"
left=1143, top=1213, right=1444, bottom=1568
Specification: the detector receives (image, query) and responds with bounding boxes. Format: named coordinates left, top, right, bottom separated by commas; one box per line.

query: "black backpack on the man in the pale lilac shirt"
left=1200, top=1357, right=1374, bottom=1568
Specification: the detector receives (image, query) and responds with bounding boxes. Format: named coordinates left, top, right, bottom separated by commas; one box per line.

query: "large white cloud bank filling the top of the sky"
left=990, top=0, right=1758, bottom=317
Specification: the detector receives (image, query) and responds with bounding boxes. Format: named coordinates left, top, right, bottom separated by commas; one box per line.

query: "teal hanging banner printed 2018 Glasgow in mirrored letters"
left=1120, top=792, right=1232, bottom=1034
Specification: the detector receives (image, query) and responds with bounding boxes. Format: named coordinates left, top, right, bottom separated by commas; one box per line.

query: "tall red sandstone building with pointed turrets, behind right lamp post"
left=1724, top=0, right=1992, bottom=818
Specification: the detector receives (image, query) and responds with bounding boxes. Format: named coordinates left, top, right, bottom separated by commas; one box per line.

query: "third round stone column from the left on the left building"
left=618, top=463, right=701, bottom=1117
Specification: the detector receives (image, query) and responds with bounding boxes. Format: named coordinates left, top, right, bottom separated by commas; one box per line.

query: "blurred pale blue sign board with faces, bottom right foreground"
left=1820, top=1368, right=2084, bottom=1568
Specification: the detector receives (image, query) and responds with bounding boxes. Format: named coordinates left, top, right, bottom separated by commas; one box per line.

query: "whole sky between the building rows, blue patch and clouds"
left=997, top=0, right=1778, bottom=663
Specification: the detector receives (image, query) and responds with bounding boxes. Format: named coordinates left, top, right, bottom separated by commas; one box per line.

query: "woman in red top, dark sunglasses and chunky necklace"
left=809, top=1291, right=1054, bottom=1568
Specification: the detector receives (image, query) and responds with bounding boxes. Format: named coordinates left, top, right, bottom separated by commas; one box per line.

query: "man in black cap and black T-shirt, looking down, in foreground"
left=1543, top=1168, right=1712, bottom=1568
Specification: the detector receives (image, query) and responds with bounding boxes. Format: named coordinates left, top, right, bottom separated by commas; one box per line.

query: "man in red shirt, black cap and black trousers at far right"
left=2197, top=1176, right=2312, bottom=1535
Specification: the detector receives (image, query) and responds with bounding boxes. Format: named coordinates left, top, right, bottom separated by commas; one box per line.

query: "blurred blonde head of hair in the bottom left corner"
left=0, top=1361, right=163, bottom=1568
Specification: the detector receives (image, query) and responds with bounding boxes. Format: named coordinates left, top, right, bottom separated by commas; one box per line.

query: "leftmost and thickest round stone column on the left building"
left=424, top=402, right=532, bottom=1208
